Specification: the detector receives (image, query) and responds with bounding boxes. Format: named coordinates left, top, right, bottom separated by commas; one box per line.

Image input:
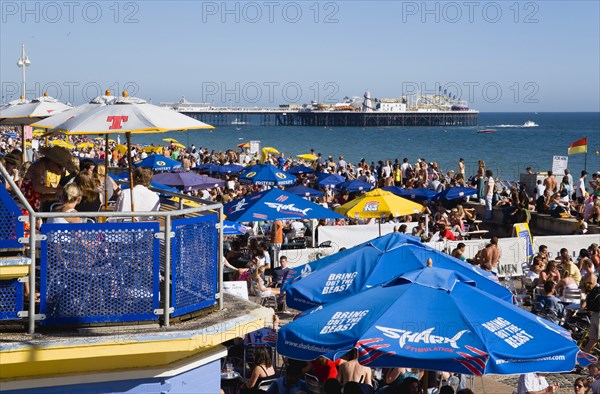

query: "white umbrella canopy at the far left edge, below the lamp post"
left=0, top=93, right=73, bottom=125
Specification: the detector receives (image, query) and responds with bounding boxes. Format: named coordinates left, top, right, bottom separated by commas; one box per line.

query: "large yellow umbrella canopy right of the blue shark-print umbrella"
left=335, top=189, right=424, bottom=218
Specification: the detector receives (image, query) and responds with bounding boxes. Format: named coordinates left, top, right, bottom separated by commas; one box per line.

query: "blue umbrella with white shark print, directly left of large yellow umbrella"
left=223, top=189, right=343, bottom=222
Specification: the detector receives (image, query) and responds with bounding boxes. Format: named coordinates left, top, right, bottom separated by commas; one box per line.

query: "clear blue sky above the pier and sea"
left=0, top=0, right=600, bottom=112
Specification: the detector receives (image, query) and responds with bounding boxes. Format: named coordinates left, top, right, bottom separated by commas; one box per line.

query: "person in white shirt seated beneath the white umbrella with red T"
left=115, top=167, right=160, bottom=220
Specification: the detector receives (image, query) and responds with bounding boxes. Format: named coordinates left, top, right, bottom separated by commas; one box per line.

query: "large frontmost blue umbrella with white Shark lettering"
left=277, top=267, right=590, bottom=375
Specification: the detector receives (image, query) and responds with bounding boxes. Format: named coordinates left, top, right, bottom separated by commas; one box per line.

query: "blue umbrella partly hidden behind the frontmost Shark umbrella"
left=282, top=233, right=512, bottom=310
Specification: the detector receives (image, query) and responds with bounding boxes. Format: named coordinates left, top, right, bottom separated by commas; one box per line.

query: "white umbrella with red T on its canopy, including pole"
left=42, top=92, right=214, bottom=210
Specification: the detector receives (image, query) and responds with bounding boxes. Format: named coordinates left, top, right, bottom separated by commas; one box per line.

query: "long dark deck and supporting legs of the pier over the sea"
left=183, top=108, right=479, bottom=127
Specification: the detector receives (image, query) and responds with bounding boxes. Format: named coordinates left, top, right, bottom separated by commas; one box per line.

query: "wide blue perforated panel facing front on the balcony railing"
left=40, top=222, right=159, bottom=324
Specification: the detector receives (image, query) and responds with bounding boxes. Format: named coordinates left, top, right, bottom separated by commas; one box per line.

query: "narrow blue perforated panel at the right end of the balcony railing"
left=171, top=215, right=219, bottom=316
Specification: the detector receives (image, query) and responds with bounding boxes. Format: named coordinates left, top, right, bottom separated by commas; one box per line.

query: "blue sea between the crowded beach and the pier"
left=132, top=112, right=600, bottom=181
